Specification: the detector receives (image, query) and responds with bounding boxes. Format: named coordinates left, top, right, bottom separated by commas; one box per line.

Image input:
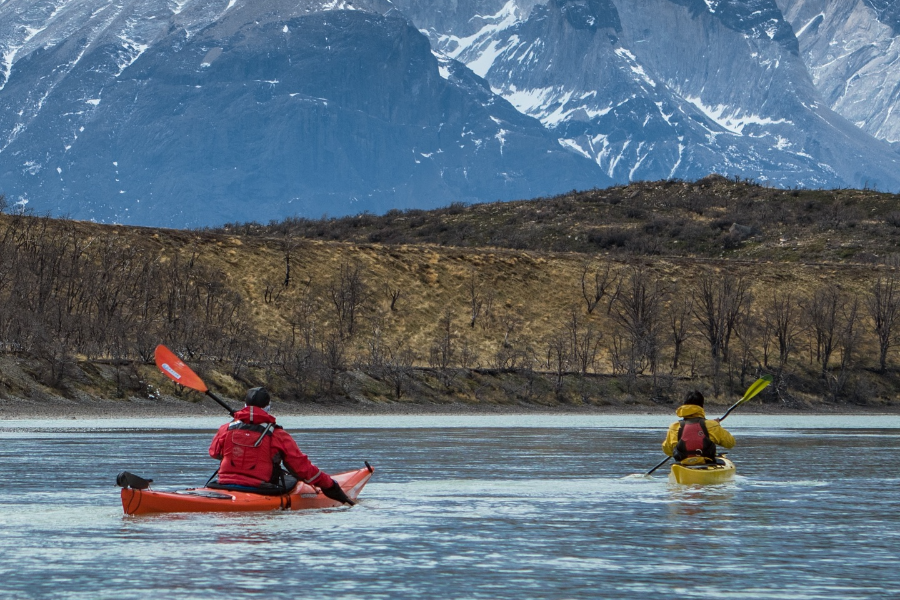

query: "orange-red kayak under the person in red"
left=122, top=463, right=375, bottom=515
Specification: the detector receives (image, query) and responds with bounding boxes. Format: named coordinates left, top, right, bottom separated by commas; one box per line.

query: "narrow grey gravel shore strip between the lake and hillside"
left=0, top=395, right=900, bottom=423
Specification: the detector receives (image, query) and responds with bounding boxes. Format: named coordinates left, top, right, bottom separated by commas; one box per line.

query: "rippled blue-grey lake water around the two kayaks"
left=0, top=414, right=900, bottom=600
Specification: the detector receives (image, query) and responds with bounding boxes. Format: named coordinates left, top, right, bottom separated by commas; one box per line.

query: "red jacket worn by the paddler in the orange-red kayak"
left=209, top=406, right=332, bottom=488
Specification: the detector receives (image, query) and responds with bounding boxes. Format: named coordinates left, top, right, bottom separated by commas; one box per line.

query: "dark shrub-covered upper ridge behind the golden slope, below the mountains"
left=207, top=176, right=900, bottom=263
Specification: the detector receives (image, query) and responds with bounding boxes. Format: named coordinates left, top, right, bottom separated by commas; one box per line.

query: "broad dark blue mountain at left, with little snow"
left=0, top=2, right=610, bottom=227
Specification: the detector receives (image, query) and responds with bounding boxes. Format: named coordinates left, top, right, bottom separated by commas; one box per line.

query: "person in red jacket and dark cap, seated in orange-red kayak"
left=209, top=387, right=353, bottom=505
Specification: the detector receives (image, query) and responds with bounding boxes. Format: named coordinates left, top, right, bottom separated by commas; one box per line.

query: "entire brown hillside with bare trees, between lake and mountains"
left=0, top=179, right=900, bottom=407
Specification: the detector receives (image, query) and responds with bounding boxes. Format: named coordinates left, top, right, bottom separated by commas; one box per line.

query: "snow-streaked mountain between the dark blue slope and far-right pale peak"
left=396, top=0, right=900, bottom=190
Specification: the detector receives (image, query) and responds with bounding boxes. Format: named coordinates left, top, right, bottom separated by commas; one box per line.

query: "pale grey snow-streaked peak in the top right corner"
left=778, top=0, right=900, bottom=151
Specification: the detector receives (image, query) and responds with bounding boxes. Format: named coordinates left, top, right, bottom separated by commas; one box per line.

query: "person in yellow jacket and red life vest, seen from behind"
left=663, top=390, right=734, bottom=462
